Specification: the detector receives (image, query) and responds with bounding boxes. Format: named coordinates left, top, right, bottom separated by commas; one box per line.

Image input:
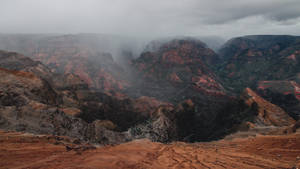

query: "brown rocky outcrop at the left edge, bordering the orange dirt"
left=0, top=63, right=138, bottom=144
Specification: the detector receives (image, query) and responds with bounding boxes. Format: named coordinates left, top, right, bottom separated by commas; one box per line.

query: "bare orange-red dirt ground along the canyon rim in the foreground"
left=0, top=131, right=300, bottom=169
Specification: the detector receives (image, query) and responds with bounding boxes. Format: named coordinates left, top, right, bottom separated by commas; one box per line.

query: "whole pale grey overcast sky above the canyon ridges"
left=0, top=0, right=300, bottom=38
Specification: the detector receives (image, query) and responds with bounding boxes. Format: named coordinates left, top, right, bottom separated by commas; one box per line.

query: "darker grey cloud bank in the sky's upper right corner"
left=188, top=0, right=300, bottom=24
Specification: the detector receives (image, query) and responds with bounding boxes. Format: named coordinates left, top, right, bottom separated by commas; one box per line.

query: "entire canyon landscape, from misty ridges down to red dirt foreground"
left=0, top=35, right=300, bottom=168
